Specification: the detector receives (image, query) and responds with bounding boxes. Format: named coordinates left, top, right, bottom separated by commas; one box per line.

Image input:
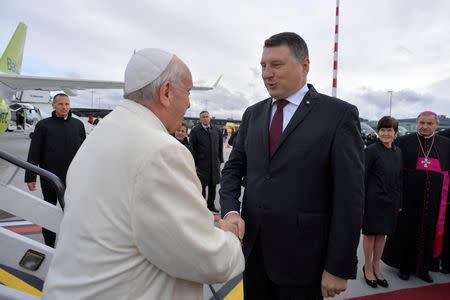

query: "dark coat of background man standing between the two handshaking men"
left=189, top=124, right=223, bottom=185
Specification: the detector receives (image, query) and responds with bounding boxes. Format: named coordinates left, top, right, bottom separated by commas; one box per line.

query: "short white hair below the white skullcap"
left=123, top=56, right=185, bottom=103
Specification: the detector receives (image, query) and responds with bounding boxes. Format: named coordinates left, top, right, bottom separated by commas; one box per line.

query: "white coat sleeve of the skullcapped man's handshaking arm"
left=131, top=144, right=244, bottom=283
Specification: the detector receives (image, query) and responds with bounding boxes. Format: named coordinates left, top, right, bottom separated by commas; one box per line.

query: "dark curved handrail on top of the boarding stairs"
left=0, top=149, right=66, bottom=210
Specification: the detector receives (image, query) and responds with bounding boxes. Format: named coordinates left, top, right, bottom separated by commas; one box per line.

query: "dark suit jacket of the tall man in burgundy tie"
left=220, top=85, right=364, bottom=285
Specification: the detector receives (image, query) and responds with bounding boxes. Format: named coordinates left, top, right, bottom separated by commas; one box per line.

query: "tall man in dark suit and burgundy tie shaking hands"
left=220, top=32, right=364, bottom=299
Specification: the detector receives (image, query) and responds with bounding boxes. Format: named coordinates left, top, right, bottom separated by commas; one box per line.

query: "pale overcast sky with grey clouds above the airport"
left=0, top=0, right=450, bottom=120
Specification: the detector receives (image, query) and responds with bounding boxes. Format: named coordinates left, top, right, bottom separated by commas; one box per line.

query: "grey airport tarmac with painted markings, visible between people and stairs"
left=0, top=128, right=450, bottom=300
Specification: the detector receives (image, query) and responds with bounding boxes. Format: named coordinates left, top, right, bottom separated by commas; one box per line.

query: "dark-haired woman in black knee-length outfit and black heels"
left=362, top=116, right=403, bottom=287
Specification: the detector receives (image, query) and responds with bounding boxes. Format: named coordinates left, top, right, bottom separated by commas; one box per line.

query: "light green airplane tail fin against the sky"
left=0, top=22, right=27, bottom=74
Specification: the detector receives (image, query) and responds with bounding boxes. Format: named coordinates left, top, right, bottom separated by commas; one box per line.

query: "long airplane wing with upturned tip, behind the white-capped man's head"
left=0, top=73, right=220, bottom=94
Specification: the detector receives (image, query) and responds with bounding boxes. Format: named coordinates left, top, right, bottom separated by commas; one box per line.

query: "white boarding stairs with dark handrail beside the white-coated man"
left=0, top=150, right=65, bottom=299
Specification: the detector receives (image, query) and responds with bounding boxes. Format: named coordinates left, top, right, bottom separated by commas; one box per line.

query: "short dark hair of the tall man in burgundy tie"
left=264, top=32, right=309, bottom=62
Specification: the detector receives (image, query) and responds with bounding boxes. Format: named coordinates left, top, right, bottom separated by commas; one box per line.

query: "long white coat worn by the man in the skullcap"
left=43, top=100, right=244, bottom=299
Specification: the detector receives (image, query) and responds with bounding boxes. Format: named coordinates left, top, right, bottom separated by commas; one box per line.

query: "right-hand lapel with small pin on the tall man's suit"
left=272, top=84, right=319, bottom=156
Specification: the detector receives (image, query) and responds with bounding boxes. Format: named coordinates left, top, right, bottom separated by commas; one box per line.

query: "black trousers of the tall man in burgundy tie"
left=244, top=235, right=323, bottom=300
